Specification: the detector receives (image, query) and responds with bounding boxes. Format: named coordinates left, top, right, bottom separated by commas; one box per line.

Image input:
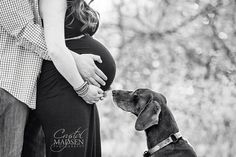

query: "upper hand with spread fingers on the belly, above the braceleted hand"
left=71, top=51, right=107, bottom=87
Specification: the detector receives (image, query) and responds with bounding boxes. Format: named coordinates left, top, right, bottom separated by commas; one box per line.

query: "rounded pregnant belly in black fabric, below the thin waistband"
left=66, top=36, right=116, bottom=90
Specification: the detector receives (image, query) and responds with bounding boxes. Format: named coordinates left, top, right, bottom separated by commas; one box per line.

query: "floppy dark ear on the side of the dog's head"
left=135, top=100, right=161, bottom=131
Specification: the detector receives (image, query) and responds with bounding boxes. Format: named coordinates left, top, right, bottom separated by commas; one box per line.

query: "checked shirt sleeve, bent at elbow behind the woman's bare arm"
left=0, top=0, right=50, bottom=60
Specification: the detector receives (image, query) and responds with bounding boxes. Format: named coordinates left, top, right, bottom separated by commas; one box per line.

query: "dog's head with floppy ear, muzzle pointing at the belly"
left=112, top=89, right=166, bottom=131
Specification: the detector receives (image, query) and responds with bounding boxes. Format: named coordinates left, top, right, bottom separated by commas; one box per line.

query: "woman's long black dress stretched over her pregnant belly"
left=35, top=5, right=115, bottom=157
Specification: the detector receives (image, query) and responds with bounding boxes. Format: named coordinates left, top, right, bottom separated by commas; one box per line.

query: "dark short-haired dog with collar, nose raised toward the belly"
left=112, top=89, right=197, bottom=157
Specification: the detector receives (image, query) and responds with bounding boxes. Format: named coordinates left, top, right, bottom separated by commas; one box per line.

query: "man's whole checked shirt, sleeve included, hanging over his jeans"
left=0, top=0, right=50, bottom=109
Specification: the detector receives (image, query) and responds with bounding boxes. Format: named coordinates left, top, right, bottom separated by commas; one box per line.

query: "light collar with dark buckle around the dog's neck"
left=143, top=132, right=182, bottom=157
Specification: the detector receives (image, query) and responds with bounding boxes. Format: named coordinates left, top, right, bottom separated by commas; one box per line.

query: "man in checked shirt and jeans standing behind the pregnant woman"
left=0, top=0, right=107, bottom=157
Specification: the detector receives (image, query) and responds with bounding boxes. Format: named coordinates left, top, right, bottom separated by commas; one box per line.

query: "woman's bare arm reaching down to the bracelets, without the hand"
left=40, top=0, right=84, bottom=88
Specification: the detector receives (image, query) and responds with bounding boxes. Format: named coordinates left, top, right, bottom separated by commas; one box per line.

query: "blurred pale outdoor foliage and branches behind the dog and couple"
left=92, top=0, right=236, bottom=157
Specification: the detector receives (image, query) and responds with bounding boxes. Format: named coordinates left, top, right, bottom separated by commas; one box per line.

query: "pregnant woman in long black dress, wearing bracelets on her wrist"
left=36, top=0, right=115, bottom=157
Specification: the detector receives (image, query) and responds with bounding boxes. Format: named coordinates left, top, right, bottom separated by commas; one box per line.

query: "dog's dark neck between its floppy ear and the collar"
left=145, top=105, right=179, bottom=149
